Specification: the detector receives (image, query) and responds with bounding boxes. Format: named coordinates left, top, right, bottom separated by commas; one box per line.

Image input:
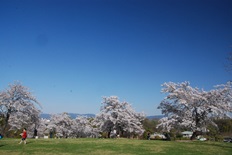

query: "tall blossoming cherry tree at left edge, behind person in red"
left=0, top=82, right=41, bottom=134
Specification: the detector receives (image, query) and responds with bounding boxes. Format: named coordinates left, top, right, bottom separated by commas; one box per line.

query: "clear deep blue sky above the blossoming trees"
left=0, top=0, right=232, bottom=115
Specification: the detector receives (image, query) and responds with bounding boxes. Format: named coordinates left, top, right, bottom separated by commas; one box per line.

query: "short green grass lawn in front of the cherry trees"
left=0, top=138, right=232, bottom=155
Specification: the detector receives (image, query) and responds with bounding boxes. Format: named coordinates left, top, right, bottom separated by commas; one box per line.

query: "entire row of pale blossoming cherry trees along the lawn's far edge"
left=0, top=82, right=232, bottom=139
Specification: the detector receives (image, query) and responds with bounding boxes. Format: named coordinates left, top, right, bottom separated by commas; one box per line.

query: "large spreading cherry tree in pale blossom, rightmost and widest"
left=157, top=82, right=232, bottom=139
